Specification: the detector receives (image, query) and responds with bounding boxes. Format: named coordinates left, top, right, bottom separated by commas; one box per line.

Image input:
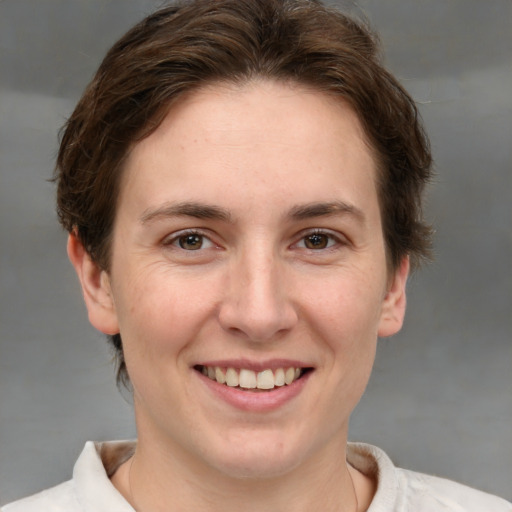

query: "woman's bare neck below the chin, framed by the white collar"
left=112, top=440, right=360, bottom=512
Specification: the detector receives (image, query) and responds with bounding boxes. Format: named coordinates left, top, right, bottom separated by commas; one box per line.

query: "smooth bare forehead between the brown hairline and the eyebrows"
left=121, top=81, right=376, bottom=222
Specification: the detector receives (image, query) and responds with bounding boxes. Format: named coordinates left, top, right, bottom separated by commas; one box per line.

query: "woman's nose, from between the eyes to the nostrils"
left=219, top=246, right=298, bottom=342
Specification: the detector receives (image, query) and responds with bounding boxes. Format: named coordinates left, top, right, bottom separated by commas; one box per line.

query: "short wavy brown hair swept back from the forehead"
left=55, top=0, right=432, bottom=383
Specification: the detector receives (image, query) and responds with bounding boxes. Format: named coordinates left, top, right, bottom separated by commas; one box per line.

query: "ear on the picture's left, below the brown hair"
left=67, top=233, right=119, bottom=334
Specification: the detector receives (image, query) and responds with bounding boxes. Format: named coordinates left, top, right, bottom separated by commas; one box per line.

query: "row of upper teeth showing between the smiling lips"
left=194, top=365, right=312, bottom=391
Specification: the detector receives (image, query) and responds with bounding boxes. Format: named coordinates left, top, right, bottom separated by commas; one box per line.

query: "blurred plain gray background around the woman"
left=0, top=0, right=512, bottom=503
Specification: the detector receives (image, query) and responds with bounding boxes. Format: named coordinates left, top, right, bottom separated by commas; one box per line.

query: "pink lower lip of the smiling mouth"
left=194, top=370, right=313, bottom=412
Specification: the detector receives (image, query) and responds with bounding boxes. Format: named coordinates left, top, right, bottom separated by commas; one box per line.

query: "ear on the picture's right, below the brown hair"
left=378, top=256, right=409, bottom=338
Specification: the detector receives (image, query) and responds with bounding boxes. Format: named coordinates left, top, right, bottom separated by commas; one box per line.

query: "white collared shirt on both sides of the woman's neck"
left=1, top=441, right=512, bottom=512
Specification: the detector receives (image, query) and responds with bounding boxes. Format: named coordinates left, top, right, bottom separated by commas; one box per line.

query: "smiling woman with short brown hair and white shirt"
left=4, top=0, right=511, bottom=512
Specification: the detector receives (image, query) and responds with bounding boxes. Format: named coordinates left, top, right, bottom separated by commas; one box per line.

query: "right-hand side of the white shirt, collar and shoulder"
left=347, top=443, right=512, bottom=512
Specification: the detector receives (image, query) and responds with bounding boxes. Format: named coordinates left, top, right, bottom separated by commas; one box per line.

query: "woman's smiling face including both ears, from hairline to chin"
left=70, top=82, right=407, bottom=476
